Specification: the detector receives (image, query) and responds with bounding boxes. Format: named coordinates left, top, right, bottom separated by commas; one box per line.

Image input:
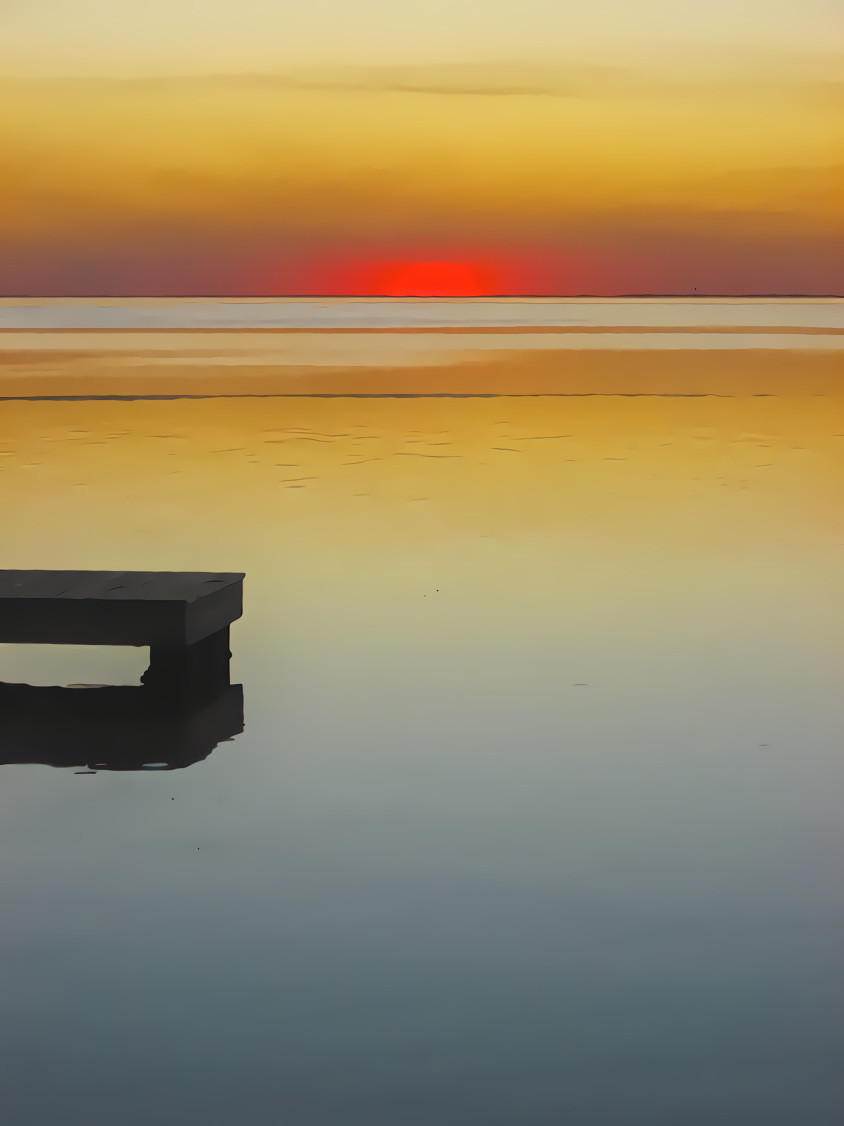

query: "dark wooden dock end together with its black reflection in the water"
left=0, top=571, right=244, bottom=770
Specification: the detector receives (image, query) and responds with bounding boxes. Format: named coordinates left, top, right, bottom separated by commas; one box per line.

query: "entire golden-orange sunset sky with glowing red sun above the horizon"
left=0, top=0, right=844, bottom=296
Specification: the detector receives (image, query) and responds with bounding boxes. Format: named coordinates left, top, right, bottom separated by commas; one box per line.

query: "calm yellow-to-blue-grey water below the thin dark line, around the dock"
left=0, top=367, right=844, bottom=1126
